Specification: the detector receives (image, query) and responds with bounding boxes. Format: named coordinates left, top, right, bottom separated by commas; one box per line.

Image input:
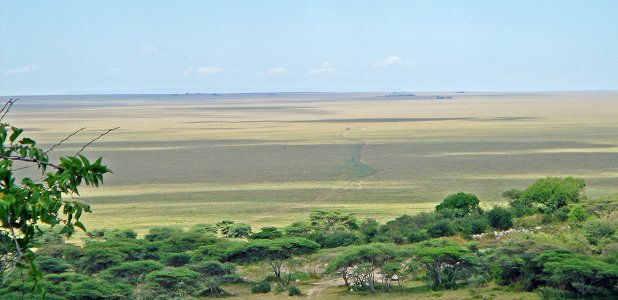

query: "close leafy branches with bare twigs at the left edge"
left=0, top=100, right=113, bottom=286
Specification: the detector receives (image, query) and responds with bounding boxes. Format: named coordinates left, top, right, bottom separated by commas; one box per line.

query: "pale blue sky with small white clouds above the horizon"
left=0, top=0, right=618, bottom=96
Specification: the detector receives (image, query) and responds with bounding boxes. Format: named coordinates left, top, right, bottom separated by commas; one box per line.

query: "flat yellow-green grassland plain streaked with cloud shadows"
left=7, top=92, right=618, bottom=232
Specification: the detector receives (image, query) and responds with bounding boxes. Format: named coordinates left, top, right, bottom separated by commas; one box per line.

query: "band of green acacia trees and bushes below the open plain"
left=0, top=177, right=618, bottom=299
